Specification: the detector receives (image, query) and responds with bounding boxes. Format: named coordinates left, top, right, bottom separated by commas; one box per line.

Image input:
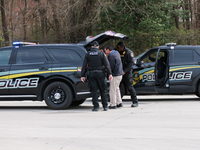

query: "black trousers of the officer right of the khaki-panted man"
left=122, top=71, right=138, bottom=103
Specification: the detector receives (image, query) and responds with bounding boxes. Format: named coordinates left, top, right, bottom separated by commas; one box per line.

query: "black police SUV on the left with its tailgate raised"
left=0, top=31, right=126, bottom=109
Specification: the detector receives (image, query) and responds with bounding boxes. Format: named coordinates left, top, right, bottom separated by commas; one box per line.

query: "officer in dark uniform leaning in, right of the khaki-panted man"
left=117, top=42, right=138, bottom=107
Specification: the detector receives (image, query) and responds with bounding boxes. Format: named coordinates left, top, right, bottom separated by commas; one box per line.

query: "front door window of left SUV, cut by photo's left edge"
left=0, top=49, right=12, bottom=65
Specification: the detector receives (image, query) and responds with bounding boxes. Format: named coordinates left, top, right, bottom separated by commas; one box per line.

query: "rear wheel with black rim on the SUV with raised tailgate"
left=44, top=82, right=73, bottom=110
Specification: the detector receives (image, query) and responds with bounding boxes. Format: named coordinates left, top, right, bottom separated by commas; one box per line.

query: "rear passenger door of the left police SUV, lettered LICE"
left=10, top=46, right=52, bottom=97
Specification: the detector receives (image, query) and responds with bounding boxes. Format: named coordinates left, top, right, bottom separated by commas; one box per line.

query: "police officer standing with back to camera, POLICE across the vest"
left=81, top=41, right=112, bottom=111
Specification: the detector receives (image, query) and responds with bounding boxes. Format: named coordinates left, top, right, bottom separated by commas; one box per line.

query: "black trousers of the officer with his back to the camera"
left=88, top=71, right=108, bottom=108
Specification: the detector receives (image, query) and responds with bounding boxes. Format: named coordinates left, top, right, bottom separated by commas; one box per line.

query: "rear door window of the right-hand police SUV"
left=171, top=50, right=194, bottom=62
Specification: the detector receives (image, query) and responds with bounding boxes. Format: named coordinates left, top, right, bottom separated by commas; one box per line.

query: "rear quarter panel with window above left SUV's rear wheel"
left=47, top=46, right=90, bottom=98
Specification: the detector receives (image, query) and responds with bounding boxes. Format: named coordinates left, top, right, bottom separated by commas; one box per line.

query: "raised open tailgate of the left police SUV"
left=82, top=31, right=128, bottom=49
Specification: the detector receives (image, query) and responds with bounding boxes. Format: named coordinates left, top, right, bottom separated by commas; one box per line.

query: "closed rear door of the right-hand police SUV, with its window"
left=169, top=46, right=200, bottom=94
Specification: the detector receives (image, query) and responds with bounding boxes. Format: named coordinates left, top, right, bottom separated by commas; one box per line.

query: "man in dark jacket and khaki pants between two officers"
left=104, top=45, right=123, bottom=109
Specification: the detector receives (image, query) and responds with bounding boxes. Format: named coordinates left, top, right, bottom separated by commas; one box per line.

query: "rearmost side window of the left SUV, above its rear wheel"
left=49, top=48, right=82, bottom=61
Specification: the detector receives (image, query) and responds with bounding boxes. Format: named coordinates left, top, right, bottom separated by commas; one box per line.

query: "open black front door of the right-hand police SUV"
left=154, top=48, right=169, bottom=93
